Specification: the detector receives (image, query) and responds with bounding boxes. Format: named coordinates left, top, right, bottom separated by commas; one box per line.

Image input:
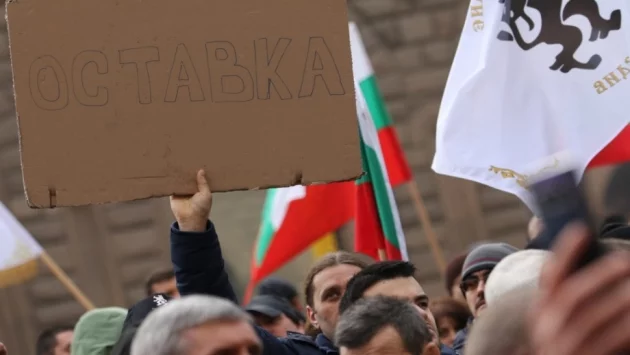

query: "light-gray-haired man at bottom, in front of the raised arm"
left=131, top=296, right=262, bottom=355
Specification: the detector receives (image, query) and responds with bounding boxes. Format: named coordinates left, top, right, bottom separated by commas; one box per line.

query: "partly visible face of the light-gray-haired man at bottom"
left=183, top=321, right=262, bottom=355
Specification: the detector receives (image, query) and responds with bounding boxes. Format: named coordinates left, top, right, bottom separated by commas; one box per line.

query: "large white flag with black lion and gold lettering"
left=433, top=0, right=630, bottom=207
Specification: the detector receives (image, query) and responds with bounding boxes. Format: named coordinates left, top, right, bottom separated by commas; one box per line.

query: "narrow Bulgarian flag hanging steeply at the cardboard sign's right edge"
left=354, top=85, right=409, bottom=260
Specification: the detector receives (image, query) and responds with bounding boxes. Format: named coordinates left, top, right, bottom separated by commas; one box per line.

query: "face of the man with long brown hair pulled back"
left=306, top=264, right=361, bottom=339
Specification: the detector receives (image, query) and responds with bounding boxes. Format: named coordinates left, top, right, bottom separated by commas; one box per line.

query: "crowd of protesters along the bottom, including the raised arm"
left=0, top=173, right=630, bottom=355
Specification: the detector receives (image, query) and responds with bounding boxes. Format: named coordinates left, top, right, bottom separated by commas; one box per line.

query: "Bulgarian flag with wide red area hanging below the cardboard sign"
left=245, top=181, right=356, bottom=302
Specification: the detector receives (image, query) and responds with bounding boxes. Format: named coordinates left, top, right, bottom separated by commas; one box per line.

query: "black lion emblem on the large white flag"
left=498, top=0, right=621, bottom=73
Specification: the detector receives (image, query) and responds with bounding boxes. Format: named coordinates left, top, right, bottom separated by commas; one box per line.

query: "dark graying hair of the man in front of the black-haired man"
left=335, top=296, right=431, bottom=355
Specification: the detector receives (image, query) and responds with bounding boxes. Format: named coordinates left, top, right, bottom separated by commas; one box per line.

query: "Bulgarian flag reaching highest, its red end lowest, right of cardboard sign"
left=350, top=22, right=412, bottom=187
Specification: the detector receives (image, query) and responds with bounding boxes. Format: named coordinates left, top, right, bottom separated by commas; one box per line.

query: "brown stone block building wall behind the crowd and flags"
left=0, top=0, right=620, bottom=354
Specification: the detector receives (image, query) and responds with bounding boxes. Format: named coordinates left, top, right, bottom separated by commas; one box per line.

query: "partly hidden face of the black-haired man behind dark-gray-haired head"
left=363, top=277, right=438, bottom=341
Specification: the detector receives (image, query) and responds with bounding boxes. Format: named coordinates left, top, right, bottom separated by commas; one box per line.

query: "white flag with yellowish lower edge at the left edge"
left=0, top=202, right=42, bottom=287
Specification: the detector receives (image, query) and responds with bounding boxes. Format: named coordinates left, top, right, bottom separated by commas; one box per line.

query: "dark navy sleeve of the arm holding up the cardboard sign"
left=171, top=221, right=238, bottom=303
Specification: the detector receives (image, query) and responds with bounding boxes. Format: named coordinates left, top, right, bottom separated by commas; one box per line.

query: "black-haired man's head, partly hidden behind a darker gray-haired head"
left=339, top=261, right=439, bottom=341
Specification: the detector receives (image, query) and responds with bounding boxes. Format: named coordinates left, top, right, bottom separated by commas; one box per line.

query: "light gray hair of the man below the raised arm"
left=131, top=296, right=251, bottom=355
